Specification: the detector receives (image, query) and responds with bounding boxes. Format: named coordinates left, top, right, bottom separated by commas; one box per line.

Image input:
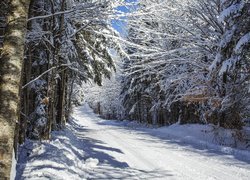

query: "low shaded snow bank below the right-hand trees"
left=114, top=121, right=250, bottom=152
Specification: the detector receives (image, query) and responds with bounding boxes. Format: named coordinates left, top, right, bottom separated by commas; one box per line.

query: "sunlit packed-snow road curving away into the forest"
left=70, top=106, right=250, bottom=180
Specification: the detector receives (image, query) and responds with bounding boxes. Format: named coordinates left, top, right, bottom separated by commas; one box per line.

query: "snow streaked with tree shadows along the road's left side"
left=16, top=119, right=172, bottom=180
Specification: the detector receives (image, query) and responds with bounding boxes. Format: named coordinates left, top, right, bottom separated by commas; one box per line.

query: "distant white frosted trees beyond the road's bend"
left=84, top=56, right=125, bottom=120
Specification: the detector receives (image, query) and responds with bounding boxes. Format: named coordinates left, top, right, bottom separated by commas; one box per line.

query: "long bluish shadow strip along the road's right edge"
left=98, top=120, right=250, bottom=166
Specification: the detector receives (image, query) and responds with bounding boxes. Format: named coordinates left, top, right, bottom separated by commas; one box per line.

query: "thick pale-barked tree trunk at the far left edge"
left=0, top=0, right=30, bottom=179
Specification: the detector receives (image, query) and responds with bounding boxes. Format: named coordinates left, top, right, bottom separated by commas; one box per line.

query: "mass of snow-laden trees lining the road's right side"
left=87, top=0, right=250, bottom=129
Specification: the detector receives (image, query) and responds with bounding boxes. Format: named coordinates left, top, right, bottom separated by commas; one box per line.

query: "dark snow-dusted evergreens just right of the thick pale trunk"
left=21, top=0, right=131, bottom=139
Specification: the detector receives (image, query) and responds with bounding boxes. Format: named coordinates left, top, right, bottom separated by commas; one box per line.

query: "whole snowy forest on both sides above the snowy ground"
left=0, top=0, right=250, bottom=179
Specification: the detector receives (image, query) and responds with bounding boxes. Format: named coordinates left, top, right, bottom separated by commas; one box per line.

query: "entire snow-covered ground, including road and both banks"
left=16, top=105, right=250, bottom=180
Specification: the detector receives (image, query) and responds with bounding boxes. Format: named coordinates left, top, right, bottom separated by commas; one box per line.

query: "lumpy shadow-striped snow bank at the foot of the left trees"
left=16, top=129, right=90, bottom=180
